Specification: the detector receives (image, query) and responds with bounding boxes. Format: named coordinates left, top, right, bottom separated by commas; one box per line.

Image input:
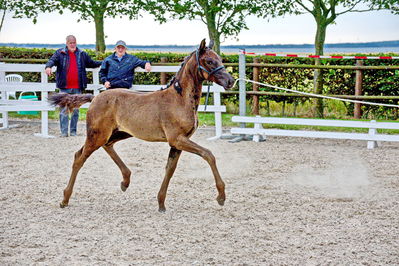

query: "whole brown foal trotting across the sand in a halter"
left=49, top=40, right=234, bottom=212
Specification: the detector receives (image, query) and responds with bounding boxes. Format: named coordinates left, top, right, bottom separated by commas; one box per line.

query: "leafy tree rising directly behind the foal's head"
left=146, top=0, right=255, bottom=53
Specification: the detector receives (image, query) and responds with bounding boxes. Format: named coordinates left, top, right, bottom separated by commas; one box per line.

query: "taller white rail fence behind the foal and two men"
left=0, top=63, right=226, bottom=139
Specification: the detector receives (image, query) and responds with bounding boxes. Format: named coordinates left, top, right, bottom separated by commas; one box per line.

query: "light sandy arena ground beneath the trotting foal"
left=0, top=123, right=399, bottom=265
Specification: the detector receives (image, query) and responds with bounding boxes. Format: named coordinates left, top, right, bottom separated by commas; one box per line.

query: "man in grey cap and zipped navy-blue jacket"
left=100, top=41, right=151, bottom=89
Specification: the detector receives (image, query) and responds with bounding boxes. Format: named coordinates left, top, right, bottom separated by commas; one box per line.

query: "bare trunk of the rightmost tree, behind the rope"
left=313, top=18, right=327, bottom=118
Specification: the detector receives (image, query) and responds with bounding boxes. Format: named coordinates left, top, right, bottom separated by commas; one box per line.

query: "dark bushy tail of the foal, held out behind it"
left=48, top=93, right=94, bottom=112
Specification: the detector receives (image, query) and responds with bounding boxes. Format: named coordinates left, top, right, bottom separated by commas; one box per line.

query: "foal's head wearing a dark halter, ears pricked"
left=190, top=39, right=234, bottom=89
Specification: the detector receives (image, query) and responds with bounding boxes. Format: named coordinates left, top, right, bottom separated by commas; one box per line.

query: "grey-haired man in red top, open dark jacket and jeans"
left=46, top=35, right=101, bottom=137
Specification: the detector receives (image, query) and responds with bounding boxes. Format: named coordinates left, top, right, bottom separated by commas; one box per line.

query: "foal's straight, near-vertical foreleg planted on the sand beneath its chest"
left=158, top=147, right=181, bottom=212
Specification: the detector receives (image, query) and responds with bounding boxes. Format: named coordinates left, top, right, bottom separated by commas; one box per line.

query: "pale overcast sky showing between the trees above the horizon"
left=0, top=7, right=399, bottom=45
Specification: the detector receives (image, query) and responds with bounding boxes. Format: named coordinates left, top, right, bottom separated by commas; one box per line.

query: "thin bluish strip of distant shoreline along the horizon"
left=0, top=40, right=399, bottom=53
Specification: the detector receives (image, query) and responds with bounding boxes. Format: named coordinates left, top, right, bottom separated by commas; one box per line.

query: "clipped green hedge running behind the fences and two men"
left=0, top=47, right=399, bottom=118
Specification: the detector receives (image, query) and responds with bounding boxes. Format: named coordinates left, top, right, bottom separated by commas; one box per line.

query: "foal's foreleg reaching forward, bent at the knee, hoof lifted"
left=173, top=136, right=226, bottom=205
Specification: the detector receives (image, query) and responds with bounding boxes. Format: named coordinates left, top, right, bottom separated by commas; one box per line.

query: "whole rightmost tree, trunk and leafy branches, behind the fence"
left=257, top=0, right=390, bottom=117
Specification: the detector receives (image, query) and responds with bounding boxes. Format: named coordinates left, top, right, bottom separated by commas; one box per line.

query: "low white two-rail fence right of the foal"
left=231, top=116, right=399, bottom=149
